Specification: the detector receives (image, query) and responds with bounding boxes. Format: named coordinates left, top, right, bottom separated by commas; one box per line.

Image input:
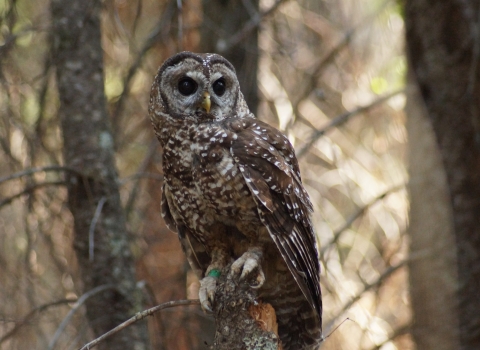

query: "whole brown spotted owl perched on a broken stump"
left=149, top=52, right=322, bottom=350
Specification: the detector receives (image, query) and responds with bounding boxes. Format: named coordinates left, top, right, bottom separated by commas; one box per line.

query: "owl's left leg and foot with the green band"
left=198, top=248, right=229, bottom=313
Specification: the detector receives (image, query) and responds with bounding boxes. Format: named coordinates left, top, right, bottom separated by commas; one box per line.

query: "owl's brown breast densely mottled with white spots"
left=163, top=119, right=260, bottom=237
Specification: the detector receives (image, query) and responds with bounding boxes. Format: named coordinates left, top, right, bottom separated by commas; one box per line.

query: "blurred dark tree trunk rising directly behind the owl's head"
left=200, top=0, right=259, bottom=114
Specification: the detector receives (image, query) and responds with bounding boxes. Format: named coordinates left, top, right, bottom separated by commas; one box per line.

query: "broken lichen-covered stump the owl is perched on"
left=213, top=265, right=281, bottom=350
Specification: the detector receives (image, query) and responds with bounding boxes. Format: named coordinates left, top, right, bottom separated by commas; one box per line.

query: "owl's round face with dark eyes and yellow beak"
left=157, top=52, right=239, bottom=120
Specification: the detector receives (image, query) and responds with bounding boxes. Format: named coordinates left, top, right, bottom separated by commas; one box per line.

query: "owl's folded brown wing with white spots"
left=230, top=119, right=322, bottom=319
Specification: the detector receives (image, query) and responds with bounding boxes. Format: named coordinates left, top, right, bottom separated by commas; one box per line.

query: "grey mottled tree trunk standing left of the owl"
left=51, top=0, right=147, bottom=349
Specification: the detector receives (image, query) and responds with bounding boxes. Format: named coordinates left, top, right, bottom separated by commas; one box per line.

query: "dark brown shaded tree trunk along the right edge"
left=405, top=0, right=480, bottom=349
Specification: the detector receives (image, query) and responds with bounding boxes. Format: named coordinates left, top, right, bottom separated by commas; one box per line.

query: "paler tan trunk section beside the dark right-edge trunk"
left=406, top=73, right=460, bottom=350
